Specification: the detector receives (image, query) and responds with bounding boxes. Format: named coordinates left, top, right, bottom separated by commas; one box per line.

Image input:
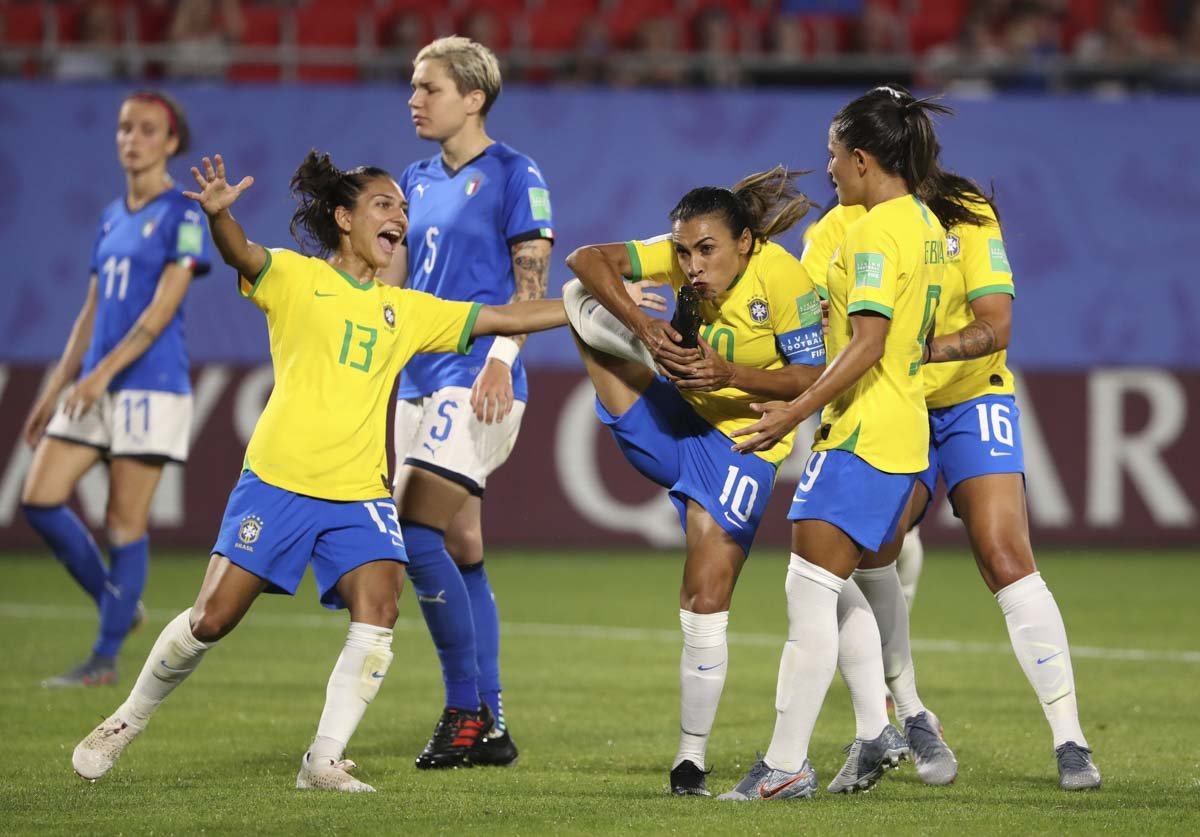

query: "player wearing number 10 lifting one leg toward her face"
left=563, top=167, right=835, bottom=796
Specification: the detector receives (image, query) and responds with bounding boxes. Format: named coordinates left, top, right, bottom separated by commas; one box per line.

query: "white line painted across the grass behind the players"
left=0, top=602, right=1200, bottom=664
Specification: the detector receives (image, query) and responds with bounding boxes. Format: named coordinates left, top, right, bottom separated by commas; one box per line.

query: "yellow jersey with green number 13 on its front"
left=239, top=249, right=480, bottom=500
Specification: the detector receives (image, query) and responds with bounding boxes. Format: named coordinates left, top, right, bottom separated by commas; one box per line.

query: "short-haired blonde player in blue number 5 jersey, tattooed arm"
left=388, top=37, right=554, bottom=769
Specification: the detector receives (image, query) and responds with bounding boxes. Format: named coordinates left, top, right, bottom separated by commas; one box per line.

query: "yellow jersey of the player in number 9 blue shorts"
left=812, top=194, right=946, bottom=474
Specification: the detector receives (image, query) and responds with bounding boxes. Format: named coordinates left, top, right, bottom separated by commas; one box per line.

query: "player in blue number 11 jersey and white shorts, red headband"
left=20, top=90, right=209, bottom=686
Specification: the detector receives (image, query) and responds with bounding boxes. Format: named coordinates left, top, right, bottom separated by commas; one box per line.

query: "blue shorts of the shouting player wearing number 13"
left=212, top=470, right=408, bottom=610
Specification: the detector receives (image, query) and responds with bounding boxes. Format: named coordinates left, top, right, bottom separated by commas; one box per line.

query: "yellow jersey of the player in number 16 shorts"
left=923, top=201, right=1016, bottom=409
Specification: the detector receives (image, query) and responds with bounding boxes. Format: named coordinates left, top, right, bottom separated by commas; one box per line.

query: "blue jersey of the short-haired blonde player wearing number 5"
left=398, top=143, right=554, bottom=401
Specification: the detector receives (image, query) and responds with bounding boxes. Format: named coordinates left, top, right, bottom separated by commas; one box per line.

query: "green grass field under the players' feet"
left=0, top=550, right=1200, bottom=835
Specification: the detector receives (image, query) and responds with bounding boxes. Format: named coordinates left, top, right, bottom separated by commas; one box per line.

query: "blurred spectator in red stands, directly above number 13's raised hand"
left=167, top=0, right=245, bottom=78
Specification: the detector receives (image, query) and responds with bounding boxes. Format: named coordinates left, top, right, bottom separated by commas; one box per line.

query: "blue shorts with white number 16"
left=918, top=396, right=1025, bottom=517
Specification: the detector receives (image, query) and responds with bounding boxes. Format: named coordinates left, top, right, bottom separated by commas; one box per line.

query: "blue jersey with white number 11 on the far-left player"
left=83, top=189, right=211, bottom=392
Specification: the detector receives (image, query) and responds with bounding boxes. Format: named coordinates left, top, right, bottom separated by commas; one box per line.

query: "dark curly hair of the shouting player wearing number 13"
left=288, top=149, right=391, bottom=257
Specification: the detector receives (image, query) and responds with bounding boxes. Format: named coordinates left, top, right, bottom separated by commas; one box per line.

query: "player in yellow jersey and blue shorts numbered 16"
left=805, top=163, right=1100, bottom=790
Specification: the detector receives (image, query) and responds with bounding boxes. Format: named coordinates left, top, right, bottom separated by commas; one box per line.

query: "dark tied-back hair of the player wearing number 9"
left=833, top=84, right=954, bottom=193
